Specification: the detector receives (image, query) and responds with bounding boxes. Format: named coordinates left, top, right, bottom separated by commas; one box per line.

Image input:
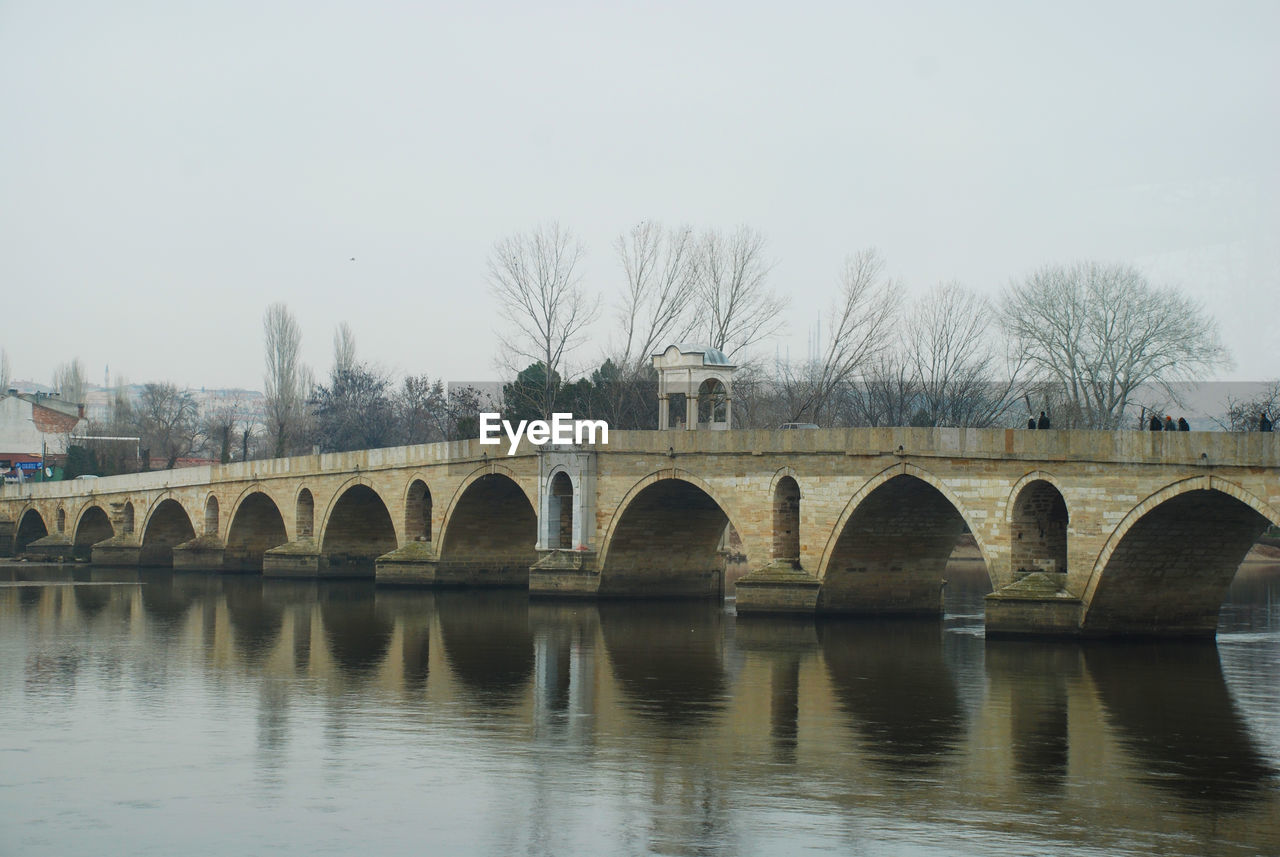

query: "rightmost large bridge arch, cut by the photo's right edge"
left=1080, top=476, right=1280, bottom=637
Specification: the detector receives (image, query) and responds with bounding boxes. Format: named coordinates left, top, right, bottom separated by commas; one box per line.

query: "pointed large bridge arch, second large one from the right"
left=818, top=462, right=992, bottom=615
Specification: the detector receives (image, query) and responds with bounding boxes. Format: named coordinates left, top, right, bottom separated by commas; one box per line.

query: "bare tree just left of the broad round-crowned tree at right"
left=906, top=283, right=1025, bottom=427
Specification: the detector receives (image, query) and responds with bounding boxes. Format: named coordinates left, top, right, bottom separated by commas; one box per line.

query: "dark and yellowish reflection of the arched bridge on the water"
left=0, top=572, right=1280, bottom=853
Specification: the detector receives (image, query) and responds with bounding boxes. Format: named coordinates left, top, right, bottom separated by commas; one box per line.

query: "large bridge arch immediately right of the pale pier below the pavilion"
left=599, top=468, right=741, bottom=597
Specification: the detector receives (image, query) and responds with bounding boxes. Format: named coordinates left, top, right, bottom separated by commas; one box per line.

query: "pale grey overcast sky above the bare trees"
left=0, top=0, right=1280, bottom=389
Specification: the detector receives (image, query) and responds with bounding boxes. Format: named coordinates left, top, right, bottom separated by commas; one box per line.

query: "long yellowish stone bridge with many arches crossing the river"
left=0, top=429, right=1280, bottom=636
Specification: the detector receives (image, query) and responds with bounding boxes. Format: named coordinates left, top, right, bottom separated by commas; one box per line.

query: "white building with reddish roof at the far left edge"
left=0, top=390, right=88, bottom=478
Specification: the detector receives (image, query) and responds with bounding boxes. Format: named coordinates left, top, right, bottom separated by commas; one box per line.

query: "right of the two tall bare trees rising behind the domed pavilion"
left=698, top=226, right=787, bottom=359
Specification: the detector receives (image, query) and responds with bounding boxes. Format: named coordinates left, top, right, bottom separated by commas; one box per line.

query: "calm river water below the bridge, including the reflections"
left=0, top=563, right=1280, bottom=857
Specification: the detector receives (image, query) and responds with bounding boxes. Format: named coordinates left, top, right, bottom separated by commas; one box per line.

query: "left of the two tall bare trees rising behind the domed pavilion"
left=613, top=221, right=699, bottom=372
